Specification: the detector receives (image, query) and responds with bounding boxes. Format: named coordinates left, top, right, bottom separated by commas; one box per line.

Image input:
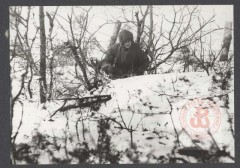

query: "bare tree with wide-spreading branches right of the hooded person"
left=116, top=5, right=221, bottom=73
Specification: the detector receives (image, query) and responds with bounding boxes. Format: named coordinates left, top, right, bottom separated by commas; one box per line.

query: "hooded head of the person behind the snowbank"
left=119, top=30, right=133, bottom=49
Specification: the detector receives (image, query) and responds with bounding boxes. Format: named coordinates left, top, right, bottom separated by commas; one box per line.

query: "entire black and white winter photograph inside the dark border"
left=8, top=5, right=235, bottom=165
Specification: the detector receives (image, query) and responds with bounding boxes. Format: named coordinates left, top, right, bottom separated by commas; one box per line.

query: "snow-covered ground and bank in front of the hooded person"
left=13, top=72, right=234, bottom=164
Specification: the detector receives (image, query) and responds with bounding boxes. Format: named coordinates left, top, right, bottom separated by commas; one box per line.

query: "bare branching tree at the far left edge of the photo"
left=10, top=7, right=38, bottom=125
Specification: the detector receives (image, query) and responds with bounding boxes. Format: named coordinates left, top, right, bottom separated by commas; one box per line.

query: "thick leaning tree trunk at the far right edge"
left=219, top=22, right=232, bottom=61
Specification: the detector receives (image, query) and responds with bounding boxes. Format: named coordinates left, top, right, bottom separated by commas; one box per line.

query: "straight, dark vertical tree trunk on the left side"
left=39, top=6, right=47, bottom=103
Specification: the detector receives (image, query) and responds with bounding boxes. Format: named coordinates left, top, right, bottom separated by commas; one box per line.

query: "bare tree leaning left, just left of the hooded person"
left=55, top=7, right=107, bottom=90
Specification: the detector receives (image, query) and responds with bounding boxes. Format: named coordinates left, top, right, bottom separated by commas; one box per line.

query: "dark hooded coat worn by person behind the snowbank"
left=101, top=30, right=149, bottom=79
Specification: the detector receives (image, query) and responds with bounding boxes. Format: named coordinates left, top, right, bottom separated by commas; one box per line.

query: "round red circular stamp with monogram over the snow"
left=180, top=99, right=221, bottom=139
